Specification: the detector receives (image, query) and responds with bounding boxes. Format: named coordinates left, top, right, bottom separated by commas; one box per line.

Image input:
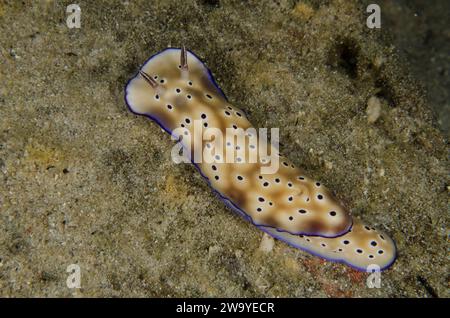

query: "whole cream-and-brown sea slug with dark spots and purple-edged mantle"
left=125, top=47, right=396, bottom=271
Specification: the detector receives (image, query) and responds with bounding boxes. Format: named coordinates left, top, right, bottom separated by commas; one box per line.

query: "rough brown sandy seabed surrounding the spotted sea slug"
left=0, top=0, right=449, bottom=297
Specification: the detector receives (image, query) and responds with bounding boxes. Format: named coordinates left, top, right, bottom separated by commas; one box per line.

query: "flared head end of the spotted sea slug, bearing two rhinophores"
left=125, top=48, right=226, bottom=131
